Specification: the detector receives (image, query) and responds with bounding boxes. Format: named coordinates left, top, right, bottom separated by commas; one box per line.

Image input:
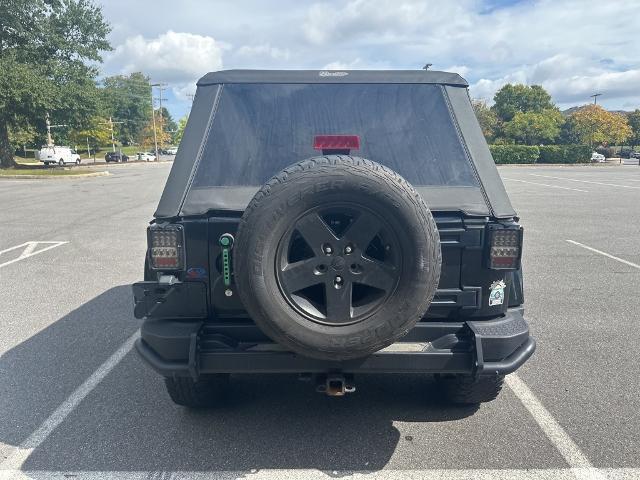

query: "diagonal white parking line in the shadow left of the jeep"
left=0, top=330, right=140, bottom=472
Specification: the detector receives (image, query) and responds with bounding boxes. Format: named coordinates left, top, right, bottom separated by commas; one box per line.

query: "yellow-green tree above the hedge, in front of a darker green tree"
left=502, top=108, right=564, bottom=145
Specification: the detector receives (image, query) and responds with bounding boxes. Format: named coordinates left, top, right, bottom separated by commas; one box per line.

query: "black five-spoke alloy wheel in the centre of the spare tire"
left=276, top=203, right=402, bottom=325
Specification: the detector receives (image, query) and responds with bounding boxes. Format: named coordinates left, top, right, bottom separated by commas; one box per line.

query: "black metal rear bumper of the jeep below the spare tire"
left=136, top=308, right=536, bottom=378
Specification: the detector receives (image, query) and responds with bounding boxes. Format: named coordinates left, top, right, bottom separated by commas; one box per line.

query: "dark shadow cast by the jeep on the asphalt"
left=0, top=286, right=476, bottom=472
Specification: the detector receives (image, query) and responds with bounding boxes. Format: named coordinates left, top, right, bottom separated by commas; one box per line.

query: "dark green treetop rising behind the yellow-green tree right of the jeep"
left=491, top=83, right=555, bottom=122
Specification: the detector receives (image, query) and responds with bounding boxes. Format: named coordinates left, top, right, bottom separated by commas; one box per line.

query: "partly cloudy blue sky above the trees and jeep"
left=95, top=0, right=640, bottom=118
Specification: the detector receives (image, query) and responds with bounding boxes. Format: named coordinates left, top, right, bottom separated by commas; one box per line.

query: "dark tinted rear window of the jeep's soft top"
left=192, top=84, right=479, bottom=189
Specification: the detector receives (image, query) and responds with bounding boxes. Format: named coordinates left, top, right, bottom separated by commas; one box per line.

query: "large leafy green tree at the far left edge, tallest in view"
left=0, top=0, right=111, bottom=167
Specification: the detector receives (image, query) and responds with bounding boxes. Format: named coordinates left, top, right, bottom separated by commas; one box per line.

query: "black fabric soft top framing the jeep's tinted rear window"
left=155, top=70, right=515, bottom=218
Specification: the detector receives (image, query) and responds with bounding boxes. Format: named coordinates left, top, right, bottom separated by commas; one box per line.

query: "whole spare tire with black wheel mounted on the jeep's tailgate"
left=234, top=155, right=441, bottom=360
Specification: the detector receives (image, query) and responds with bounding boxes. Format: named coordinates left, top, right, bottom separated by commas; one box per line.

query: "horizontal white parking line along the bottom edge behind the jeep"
left=5, top=468, right=640, bottom=480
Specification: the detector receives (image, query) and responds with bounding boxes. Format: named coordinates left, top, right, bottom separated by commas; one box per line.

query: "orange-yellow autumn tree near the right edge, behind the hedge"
left=569, top=105, right=633, bottom=145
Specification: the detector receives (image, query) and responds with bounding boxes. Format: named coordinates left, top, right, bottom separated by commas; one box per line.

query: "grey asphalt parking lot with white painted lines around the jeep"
left=0, top=163, right=640, bottom=479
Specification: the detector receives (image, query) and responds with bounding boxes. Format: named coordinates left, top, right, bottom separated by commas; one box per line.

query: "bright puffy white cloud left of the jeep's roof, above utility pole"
left=106, top=30, right=229, bottom=84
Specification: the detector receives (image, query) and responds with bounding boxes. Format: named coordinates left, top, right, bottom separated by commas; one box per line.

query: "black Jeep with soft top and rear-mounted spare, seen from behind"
left=133, top=70, right=535, bottom=407
